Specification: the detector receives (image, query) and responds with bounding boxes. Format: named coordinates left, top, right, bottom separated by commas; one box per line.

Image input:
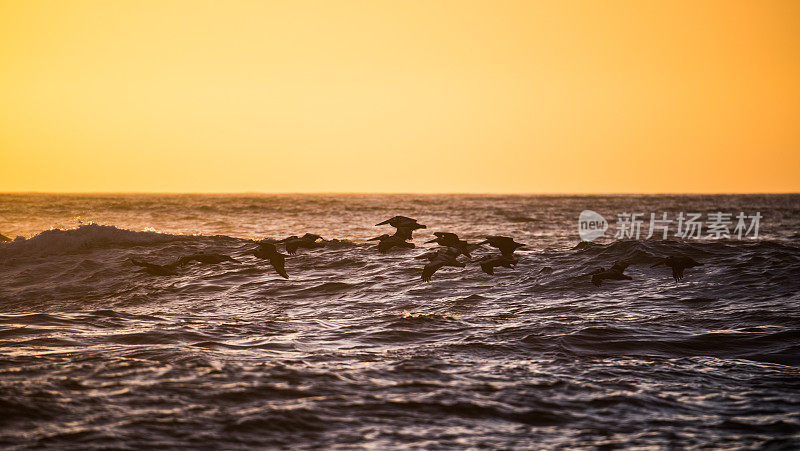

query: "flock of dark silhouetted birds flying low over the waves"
left=122, top=216, right=702, bottom=287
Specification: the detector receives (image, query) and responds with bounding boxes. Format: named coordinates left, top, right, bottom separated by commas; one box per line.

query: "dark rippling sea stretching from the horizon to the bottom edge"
left=0, top=194, right=800, bottom=449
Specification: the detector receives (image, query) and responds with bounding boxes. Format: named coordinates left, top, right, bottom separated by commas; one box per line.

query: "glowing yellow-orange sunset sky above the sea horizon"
left=0, top=0, right=800, bottom=193
